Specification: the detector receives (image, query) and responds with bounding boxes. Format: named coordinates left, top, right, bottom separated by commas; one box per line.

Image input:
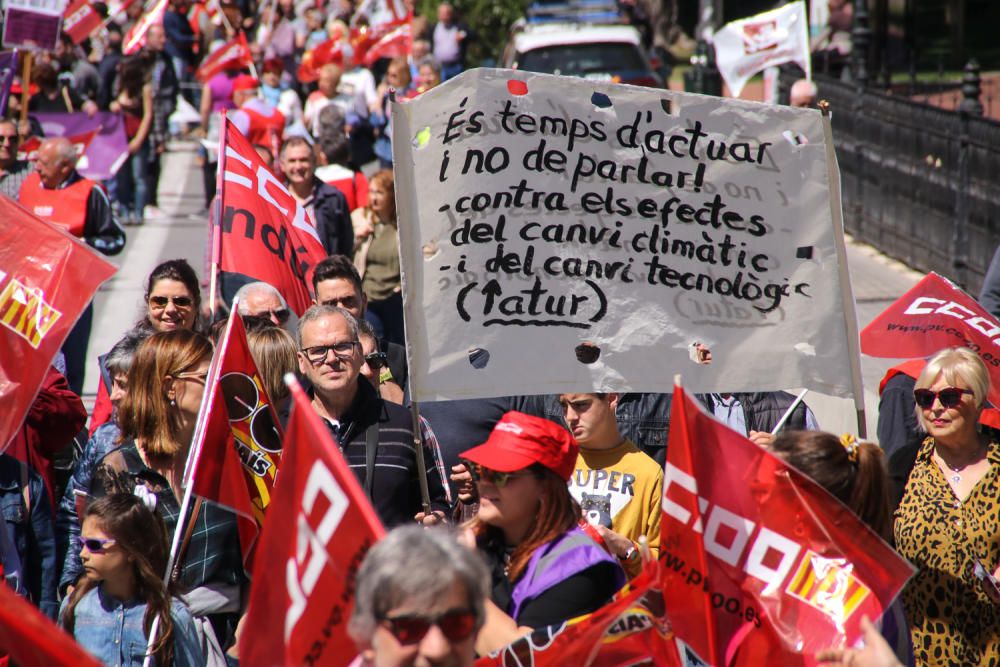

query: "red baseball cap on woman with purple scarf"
left=459, top=411, right=580, bottom=481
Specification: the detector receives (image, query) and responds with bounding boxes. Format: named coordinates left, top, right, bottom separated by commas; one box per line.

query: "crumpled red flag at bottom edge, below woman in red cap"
left=476, top=559, right=681, bottom=667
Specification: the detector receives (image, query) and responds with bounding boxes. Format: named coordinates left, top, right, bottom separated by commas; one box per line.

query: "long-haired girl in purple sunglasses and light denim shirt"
left=60, top=486, right=205, bottom=667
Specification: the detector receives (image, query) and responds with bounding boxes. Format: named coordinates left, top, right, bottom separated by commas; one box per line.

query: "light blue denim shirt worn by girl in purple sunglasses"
left=63, top=586, right=205, bottom=667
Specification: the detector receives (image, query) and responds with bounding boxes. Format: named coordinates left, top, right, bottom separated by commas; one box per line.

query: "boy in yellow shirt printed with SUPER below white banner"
left=559, top=394, right=663, bottom=577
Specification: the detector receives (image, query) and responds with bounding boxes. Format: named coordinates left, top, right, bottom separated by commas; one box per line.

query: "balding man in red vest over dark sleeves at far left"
left=19, top=137, right=125, bottom=394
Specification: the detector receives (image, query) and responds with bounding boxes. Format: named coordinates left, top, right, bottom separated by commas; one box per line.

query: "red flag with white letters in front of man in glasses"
left=240, top=379, right=385, bottom=667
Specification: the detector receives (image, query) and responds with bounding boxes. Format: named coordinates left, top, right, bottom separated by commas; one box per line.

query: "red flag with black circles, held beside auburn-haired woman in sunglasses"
left=192, top=308, right=281, bottom=563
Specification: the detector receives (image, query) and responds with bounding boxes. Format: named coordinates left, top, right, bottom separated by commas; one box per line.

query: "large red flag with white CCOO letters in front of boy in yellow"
left=660, top=386, right=912, bottom=665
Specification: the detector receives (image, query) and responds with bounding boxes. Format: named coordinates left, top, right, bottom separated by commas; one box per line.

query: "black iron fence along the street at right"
left=816, top=67, right=1000, bottom=296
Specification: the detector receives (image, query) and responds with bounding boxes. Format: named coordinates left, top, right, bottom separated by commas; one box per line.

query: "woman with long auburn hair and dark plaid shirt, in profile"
left=83, top=329, right=245, bottom=655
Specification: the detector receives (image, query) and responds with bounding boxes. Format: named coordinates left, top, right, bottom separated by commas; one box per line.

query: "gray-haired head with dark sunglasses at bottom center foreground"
left=348, top=526, right=489, bottom=667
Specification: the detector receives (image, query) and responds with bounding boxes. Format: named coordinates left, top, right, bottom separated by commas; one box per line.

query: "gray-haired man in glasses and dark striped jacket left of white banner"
left=298, top=306, right=449, bottom=528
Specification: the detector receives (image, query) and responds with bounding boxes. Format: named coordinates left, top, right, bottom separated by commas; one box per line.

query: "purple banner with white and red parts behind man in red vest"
left=31, top=111, right=128, bottom=181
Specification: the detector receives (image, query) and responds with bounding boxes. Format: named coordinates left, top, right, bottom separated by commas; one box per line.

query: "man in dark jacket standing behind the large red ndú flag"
left=281, top=137, right=354, bottom=257
